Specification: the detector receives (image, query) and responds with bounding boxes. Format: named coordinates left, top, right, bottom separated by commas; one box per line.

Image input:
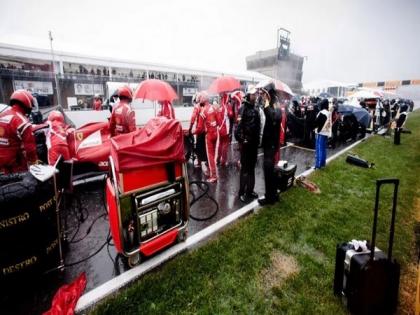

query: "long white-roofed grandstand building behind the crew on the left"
left=0, top=43, right=267, bottom=108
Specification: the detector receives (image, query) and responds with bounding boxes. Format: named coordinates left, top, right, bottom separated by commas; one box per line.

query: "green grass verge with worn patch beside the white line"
left=93, top=111, right=420, bottom=315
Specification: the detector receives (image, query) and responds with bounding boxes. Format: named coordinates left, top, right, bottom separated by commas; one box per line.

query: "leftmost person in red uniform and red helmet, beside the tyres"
left=0, top=90, right=37, bottom=174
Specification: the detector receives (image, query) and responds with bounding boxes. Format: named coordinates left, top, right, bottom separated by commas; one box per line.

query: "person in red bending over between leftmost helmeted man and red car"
left=47, top=110, right=71, bottom=165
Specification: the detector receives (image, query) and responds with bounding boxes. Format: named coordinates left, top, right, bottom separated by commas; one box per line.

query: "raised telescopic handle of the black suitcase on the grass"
left=370, top=178, right=400, bottom=260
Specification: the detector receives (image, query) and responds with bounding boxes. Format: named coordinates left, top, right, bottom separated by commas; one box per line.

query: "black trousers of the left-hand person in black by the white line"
left=239, top=143, right=258, bottom=196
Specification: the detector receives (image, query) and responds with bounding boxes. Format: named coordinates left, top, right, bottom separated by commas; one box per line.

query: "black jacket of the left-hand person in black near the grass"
left=235, top=100, right=261, bottom=145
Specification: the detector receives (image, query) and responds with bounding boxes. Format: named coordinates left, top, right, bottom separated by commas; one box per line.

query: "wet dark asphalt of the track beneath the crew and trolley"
left=0, top=142, right=353, bottom=314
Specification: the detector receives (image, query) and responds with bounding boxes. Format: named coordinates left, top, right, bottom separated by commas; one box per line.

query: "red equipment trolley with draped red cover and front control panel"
left=106, top=117, right=189, bottom=266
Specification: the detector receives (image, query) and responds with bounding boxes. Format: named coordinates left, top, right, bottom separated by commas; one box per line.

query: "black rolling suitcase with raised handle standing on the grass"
left=334, top=179, right=400, bottom=314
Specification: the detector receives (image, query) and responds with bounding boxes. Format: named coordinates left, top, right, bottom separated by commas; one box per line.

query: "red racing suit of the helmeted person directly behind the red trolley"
left=109, top=100, right=136, bottom=137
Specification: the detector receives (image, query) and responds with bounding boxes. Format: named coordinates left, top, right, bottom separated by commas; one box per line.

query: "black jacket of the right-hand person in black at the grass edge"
left=262, top=105, right=281, bottom=149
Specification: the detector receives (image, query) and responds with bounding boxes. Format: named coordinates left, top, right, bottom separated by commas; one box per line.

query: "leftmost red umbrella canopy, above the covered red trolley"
left=134, top=79, right=178, bottom=102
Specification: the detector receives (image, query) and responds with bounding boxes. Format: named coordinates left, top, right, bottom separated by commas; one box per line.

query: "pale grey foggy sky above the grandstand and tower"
left=0, top=0, right=420, bottom=82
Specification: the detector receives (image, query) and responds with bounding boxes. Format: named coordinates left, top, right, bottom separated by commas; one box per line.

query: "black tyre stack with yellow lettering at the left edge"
left=0, top=173, right=61, bottom=283
